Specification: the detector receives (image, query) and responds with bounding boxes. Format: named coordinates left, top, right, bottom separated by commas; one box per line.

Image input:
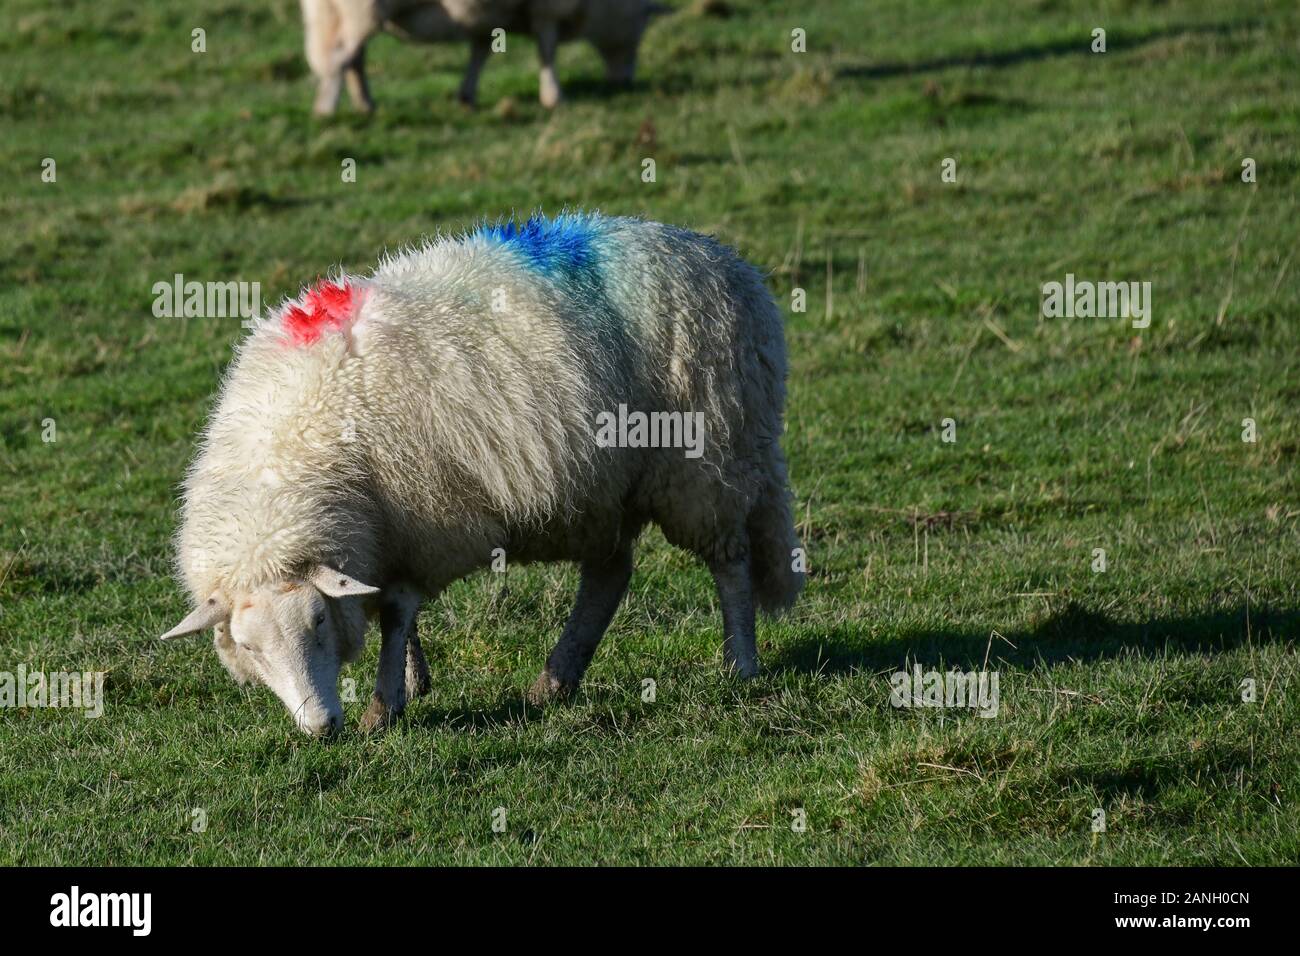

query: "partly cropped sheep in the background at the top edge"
left=300, top=0, right=667, bottom=116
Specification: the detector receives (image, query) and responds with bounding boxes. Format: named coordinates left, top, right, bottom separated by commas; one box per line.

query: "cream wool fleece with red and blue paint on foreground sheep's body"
left=178, top=215, right=787, bottom=601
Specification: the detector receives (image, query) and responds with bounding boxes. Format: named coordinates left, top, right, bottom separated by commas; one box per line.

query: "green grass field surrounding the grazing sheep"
left=0, top=0, right=1300, bottom=865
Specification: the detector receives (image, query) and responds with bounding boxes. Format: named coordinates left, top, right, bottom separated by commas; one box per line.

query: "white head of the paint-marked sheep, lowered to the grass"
left=163, top=566, right=378, bottom=735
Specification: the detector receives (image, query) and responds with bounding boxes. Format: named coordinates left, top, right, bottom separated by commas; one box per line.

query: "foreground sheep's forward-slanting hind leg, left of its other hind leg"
left=528, top=548, right=632, bottom=704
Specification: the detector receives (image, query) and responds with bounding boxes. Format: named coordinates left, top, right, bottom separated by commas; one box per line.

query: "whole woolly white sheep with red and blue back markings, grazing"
left=164, top=215, right=803, bottom=734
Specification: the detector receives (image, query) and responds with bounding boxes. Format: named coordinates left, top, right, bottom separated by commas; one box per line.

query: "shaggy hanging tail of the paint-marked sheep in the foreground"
left=746, top=449, right=806, bottom=617
